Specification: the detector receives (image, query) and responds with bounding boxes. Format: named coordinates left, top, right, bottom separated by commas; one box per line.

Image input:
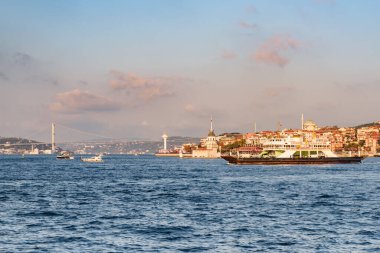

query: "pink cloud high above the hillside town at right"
left=252, top=35, right=300, bottom=67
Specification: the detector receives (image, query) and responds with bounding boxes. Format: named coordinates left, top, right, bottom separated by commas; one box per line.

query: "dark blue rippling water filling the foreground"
left=0, top=156, right=380, bottom=252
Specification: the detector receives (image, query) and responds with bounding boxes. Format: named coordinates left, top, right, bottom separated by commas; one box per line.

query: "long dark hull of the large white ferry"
left=222, top=156, right=364, bottom=165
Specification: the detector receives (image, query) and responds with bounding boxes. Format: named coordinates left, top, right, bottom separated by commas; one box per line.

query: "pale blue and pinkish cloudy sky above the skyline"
left=0, top=0, right=380, bottom=141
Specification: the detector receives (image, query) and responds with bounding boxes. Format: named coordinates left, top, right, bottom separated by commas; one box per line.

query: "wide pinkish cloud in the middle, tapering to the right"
left=109, top=70, right=180, bottom=101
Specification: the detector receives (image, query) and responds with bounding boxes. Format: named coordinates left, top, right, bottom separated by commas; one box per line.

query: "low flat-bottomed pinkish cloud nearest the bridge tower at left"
left=50, top=89, right=120, bottom=113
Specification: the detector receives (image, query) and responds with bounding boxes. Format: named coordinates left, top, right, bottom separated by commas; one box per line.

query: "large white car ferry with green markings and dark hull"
left=221, top=136, right=365, bottom=165
